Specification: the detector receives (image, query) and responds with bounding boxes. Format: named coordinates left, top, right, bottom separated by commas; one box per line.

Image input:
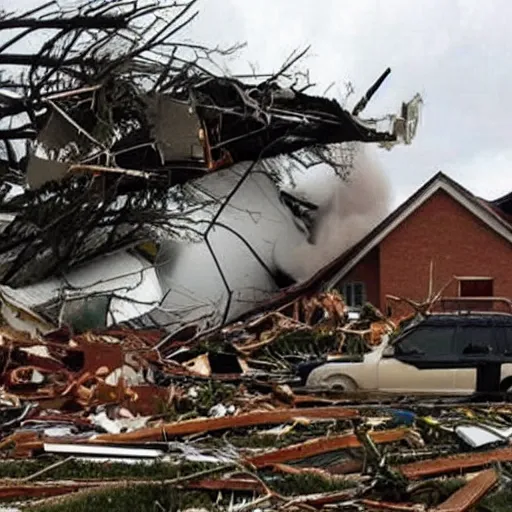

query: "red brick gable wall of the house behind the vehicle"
left=379, top=191, right=512, bottom=314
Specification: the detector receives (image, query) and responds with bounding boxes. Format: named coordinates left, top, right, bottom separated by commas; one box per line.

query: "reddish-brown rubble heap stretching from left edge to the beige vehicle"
left=1, top=292, right=384, bottom=414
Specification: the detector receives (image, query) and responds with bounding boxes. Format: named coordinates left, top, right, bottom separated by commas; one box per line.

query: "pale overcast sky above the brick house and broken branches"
left=2, top=0, right=512, bottom=208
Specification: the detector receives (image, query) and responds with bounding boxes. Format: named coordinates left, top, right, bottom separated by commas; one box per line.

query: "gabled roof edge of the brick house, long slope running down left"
left=233, top=172, right=512, bottom=318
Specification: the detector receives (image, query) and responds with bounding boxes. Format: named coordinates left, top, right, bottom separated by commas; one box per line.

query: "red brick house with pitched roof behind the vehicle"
left=324, top=172, right=512, bottom=312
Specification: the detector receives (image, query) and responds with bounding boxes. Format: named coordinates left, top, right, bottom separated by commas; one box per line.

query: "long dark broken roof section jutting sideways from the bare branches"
left=22, top=71, right=421, bottom=188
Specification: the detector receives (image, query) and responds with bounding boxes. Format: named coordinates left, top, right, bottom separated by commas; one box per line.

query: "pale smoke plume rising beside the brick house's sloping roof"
left=274, top=144, right=391, bottom=282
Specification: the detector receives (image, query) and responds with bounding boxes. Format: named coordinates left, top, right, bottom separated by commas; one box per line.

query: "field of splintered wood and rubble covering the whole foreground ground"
left=0, top=293, right=512, bottom=512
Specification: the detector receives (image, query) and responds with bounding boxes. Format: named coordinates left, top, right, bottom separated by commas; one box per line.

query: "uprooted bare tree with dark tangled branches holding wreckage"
left=0, top=0, right=419, bottom=328
